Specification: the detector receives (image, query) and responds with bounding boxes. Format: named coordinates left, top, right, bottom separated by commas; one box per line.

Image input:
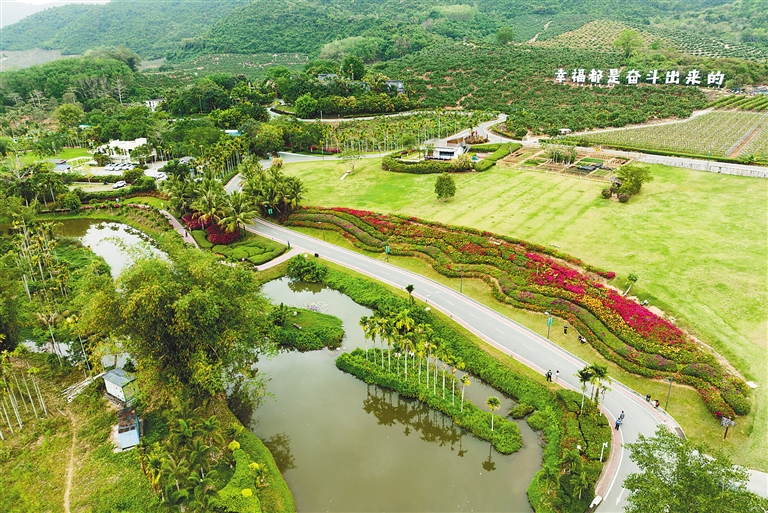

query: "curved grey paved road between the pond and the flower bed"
left=251, top=216, right=688, bottom=512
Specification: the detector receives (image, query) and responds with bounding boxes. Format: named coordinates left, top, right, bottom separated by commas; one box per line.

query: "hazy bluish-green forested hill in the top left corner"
left=0, top=0, right=248, bottom=59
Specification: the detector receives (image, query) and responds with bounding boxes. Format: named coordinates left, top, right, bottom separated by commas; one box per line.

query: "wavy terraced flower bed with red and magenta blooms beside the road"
left=286, top=207, right=750, bottom=416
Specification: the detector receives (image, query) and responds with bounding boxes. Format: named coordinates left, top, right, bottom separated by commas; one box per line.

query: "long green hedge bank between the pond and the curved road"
left=312, top=262, right=611, bottom=512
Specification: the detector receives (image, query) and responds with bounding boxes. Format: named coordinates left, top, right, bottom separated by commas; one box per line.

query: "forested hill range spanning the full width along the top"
left=0, top=0, right=768, bottom=60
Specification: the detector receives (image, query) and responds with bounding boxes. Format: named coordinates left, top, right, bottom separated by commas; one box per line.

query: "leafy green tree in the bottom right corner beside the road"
left=624, top=425, right=768, bottom=513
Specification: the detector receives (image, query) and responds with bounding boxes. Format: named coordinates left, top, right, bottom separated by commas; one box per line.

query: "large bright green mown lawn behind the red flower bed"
left=284, top=155, right=768, bottom=470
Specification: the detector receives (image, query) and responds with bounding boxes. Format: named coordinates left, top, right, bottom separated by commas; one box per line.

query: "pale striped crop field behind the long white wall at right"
left=578, top=111, right=768, bottom=157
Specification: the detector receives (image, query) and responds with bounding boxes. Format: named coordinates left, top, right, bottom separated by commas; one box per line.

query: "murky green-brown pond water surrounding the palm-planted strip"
left=249, top=279, right=542, bottom=511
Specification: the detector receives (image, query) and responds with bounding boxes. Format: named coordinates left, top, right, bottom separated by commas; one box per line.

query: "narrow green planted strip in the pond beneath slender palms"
left=336, top=348, right=523, bottom=454
